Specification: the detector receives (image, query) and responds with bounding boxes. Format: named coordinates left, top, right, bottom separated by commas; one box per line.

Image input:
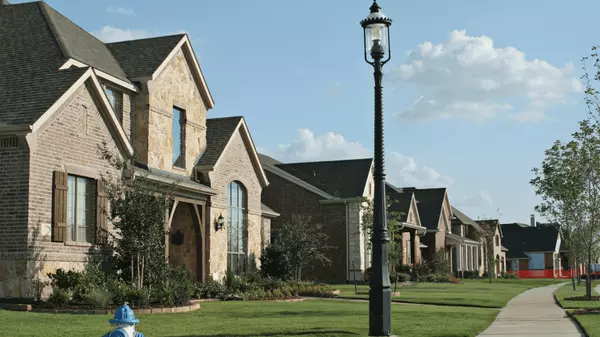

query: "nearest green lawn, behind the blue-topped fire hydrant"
left=0, top=300, right=498, bottom=337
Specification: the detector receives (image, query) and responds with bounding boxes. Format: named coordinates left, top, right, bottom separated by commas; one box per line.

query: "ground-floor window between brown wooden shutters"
left=65, top=174, right=98, bottom=244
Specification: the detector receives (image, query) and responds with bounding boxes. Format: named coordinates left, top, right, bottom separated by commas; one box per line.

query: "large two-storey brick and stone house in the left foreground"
left=0, top=2, right=278, bottom=297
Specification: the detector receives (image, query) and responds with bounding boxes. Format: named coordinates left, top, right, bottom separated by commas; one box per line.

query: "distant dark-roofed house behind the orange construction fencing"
left=501, top=222, right=562, bottom=277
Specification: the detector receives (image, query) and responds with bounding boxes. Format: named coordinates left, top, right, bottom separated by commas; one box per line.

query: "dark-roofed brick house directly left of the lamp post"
left=259, top=154, right=374, bottom=282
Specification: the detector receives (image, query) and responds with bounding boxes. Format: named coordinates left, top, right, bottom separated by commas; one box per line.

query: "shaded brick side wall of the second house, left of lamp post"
left=262, top=171, right=347, bottom=282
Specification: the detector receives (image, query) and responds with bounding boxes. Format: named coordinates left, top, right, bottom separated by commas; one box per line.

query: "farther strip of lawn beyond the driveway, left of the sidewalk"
left=335, top=279, right=565, bottom=308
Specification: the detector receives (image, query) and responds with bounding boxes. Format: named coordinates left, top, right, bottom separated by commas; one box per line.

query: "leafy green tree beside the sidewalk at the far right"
left=531, top=119, right=600, bottom=299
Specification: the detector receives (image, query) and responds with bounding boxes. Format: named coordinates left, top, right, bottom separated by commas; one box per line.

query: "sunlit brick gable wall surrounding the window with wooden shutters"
left=21, top=85, right=123, bottom=295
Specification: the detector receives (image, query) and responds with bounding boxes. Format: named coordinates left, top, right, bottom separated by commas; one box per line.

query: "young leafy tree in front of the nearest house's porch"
left=98, top=143, right=175, bottom=289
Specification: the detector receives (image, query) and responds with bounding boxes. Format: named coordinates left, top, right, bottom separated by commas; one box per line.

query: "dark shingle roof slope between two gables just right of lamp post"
left=402, top=187, right=446, bottom=229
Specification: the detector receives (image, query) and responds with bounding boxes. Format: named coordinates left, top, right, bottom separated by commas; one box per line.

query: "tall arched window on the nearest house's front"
left=227, top=181, right=247, bottom=275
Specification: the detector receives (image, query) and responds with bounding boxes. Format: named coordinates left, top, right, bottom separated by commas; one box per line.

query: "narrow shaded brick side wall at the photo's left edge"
left=0, top=137, right=29, bottom=297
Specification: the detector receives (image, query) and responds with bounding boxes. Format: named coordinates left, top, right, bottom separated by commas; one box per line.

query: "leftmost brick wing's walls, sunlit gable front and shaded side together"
left=0, top=85, right=124, bottom=297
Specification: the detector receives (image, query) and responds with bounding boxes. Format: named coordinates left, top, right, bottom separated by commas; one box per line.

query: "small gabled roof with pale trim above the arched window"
left=196, top=116, right=269, bottom=186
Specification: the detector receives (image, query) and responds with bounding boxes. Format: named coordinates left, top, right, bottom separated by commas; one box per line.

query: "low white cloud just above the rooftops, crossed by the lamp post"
left=259, top=129, right=452, bottom=187
